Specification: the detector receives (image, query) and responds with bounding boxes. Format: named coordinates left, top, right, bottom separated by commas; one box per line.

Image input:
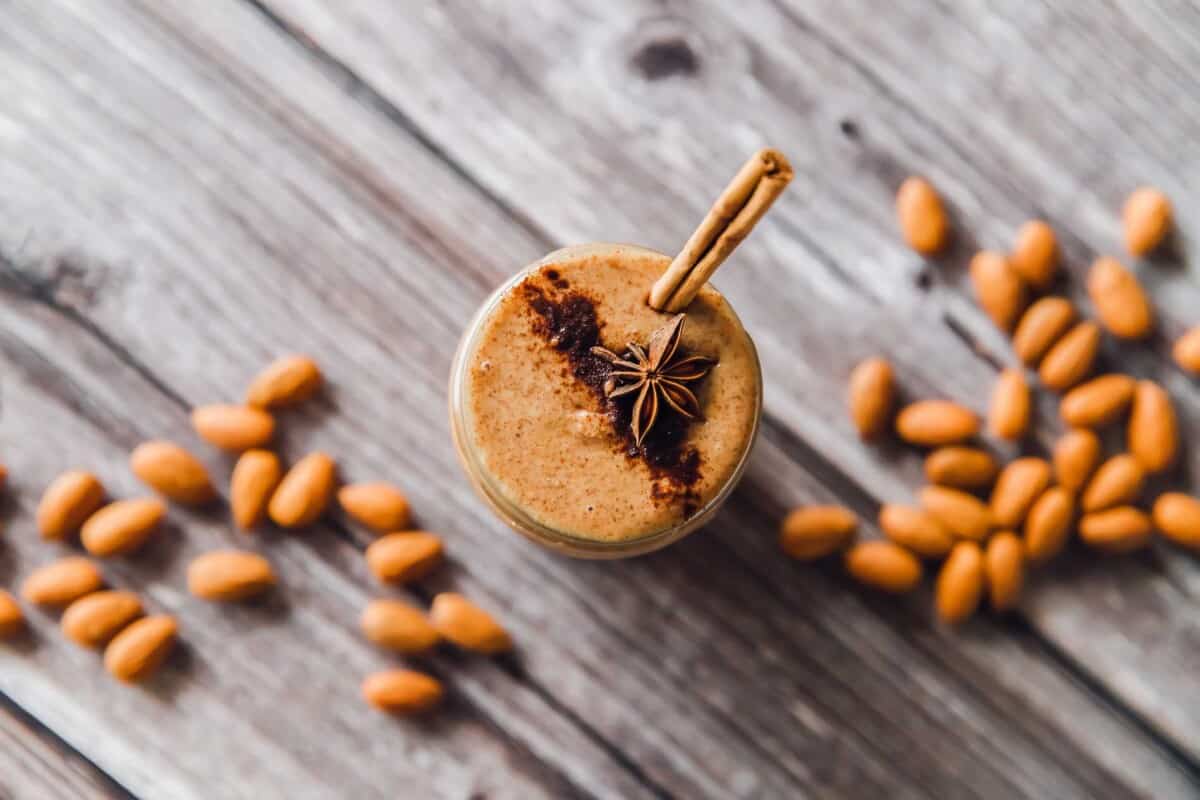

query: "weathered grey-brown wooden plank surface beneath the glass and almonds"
left=0, top=0, right=1200, bottom=799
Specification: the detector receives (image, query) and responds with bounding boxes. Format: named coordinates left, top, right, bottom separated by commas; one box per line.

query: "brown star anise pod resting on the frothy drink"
left=592, top=314, right=716, bottom=447
